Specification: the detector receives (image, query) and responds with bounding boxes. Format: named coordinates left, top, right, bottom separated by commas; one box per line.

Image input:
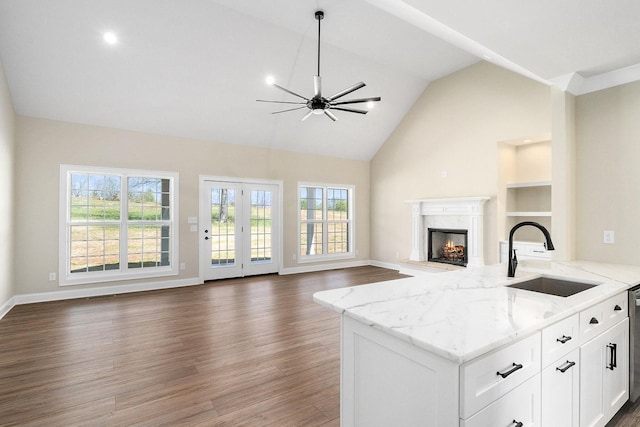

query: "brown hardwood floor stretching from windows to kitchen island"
left=0, top=267, right=403, bottom=426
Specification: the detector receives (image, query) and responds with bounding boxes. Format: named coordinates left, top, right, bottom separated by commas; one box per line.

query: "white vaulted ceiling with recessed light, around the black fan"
left=0, top=0, right=640, bottom=160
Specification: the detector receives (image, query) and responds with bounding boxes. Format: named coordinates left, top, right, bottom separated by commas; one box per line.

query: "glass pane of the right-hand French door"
left=251, top=190, right=272, bottom=262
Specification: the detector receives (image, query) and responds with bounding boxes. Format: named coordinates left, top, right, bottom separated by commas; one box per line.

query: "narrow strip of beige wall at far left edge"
left=0, top=57, right=15, bottom=311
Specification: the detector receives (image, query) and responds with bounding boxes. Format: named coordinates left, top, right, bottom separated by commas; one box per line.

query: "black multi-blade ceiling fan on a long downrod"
left=256, top=10, right=381, bottom=121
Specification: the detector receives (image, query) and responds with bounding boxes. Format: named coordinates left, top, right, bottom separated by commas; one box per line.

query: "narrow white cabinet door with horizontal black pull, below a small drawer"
left=542, top=348, right=580, bottom=427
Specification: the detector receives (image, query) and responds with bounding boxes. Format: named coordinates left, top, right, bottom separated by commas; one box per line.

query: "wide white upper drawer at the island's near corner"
left=460, top=332, right=540, bottom=419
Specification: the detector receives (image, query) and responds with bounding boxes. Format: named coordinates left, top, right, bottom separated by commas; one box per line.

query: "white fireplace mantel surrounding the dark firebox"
left=406, top=197, right=490, bottom=266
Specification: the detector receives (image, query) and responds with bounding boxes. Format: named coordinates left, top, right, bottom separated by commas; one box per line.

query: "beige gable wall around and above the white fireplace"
left=371, top=62, right=551, bottom=263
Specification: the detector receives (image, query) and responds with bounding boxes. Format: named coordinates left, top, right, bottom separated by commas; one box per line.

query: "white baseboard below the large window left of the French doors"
left=13, top=277, right=202, bottom=313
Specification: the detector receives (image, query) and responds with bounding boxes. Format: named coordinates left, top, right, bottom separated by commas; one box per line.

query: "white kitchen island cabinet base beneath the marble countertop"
left=340, top=293, right=629, bottom=427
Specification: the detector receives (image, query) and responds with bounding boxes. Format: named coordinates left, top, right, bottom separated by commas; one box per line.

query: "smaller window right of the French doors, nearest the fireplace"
left=298, top=184, right=354, bottom=262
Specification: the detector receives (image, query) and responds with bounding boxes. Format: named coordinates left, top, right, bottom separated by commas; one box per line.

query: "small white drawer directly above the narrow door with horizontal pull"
left=542, top=313, right=580, bottom=368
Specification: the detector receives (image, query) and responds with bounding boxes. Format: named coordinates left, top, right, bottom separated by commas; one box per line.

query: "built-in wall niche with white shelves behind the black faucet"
left=498, top=137, right=553, bottom=242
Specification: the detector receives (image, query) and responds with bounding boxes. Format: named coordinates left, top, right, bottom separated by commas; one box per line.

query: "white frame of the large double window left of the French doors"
left=58, top=164, right=180, bottom=286
